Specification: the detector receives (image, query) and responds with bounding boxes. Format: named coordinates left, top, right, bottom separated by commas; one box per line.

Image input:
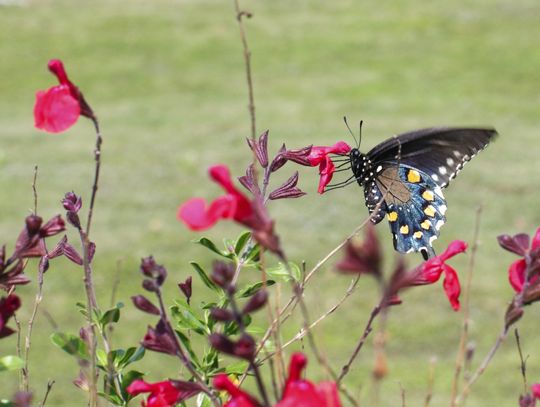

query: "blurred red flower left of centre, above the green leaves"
left=177, top=165, right=253, bottom=230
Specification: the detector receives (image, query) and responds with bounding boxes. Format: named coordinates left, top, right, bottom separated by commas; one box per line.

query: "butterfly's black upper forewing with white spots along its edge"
left=367, top=127, right=497, bottom=188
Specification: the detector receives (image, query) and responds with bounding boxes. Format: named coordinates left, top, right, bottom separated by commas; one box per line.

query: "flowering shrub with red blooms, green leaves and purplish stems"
left=0, top=15, right=540, bottom=407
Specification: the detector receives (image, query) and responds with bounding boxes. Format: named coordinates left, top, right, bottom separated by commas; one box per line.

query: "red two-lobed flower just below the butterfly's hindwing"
left=411, top=240, right=467, bottom=311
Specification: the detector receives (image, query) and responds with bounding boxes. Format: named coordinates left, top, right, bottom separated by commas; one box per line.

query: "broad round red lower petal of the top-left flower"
left=34, top=85, right=81, bottom=133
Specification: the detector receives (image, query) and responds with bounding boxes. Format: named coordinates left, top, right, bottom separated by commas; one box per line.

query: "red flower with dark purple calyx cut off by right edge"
left=498, top=228, right=540, bottom=294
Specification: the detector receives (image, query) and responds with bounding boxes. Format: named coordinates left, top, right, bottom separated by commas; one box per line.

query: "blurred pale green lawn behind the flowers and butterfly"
left=0, top=0, right=540, bottom=407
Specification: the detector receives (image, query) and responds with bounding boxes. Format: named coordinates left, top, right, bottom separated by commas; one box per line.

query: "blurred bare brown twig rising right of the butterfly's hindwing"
left=450, top=206, right=482, bottom=407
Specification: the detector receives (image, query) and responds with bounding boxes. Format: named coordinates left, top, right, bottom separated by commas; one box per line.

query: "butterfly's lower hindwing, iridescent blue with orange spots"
left=375, top=165, right=447, bottom=257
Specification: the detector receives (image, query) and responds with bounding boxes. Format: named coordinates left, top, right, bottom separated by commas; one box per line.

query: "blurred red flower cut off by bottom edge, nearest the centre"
left=276, top=353, right=341, bottom=407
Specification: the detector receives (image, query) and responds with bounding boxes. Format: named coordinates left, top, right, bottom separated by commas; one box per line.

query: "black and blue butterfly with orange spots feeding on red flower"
left=329, top=124, right=497, bottom=260
